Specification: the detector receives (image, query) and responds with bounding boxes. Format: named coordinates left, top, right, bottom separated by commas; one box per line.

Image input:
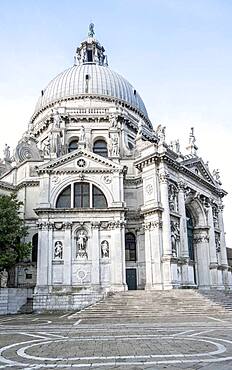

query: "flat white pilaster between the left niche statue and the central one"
left=63, top=222, right=72, bottom=288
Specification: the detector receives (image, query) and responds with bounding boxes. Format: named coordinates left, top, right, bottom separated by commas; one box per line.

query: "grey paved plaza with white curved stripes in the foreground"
left=0, top=312, right=232, bottom=370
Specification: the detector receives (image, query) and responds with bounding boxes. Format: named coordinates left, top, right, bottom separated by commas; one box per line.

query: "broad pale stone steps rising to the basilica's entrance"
left=75, top=289, right=232, bottom=322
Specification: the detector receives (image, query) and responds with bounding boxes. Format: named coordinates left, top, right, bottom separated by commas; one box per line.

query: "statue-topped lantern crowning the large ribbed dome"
left=74, top=23, right=108, bottom=67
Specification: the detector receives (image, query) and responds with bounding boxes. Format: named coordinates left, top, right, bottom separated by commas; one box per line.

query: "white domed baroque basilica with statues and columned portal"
left=0, top=24, right=232, bottom=311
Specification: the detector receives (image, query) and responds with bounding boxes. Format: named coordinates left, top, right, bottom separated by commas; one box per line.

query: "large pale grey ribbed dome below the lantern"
left=34, top=63, right=148, bottom=118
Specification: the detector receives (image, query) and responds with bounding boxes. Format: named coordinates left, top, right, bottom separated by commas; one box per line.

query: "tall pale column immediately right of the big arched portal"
left=208, top=205, right=218, bottom=287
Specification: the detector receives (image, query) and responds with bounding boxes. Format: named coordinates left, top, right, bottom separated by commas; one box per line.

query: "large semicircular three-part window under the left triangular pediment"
left=56, top=182, right=108, bottom=208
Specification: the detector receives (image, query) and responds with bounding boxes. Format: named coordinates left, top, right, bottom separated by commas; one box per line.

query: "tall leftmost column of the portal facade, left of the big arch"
left=159, top=164, right=172, bottom=289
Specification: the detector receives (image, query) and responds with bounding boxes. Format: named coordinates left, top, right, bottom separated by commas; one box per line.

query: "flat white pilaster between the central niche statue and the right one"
left=91, top=222, right=100, bottom=288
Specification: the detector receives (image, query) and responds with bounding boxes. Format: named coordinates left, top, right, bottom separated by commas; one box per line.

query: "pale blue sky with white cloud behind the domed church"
left=0, top=0, right=232, bottom=246
